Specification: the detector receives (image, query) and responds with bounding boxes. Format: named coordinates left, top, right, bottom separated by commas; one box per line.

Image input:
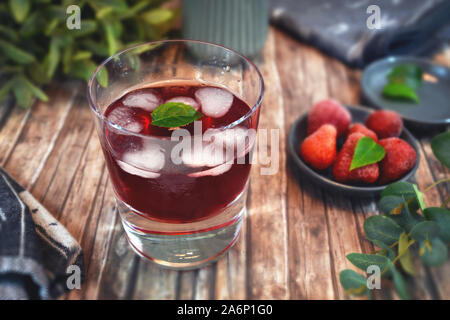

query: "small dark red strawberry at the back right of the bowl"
left=366, top=110, right=403, bottom=139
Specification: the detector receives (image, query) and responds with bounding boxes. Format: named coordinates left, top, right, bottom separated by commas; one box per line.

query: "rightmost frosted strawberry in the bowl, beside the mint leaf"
left=379, top=138, right=417, bottom=184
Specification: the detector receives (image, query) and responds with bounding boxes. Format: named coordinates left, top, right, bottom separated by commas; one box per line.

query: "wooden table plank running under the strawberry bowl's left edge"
left=276, top=28, right=335, bottom=299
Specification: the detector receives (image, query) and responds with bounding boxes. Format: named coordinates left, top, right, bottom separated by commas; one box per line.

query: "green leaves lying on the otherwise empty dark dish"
left=383, top=63, right=423, bottom=103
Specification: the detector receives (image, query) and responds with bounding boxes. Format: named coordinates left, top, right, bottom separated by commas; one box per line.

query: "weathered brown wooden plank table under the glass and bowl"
left=0, top=28, right=450, bottom=299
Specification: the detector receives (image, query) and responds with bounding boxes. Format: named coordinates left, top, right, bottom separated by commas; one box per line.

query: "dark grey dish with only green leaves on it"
left=361, top=57, right=450, bottom=127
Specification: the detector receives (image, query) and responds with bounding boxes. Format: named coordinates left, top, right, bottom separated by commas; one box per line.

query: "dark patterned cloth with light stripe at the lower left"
left=0, top=168, right=84, bottom=300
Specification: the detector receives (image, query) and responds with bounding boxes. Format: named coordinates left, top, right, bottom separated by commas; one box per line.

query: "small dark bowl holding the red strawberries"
left=288, top=106, right=420, bottom=197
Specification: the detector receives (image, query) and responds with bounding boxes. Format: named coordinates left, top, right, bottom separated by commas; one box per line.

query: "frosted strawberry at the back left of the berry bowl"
left=307, top=100, right=352, bottom=137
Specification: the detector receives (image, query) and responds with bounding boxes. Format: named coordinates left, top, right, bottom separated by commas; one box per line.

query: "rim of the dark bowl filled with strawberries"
left=288, top=104, right=421, bottom=193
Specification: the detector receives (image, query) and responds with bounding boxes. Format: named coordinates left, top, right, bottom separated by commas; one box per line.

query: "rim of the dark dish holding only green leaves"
left=360, top=56, right=450, bottom=125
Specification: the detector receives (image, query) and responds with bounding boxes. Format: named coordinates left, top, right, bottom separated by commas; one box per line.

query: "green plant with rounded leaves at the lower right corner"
left=339, top=132, right=450, bottom=299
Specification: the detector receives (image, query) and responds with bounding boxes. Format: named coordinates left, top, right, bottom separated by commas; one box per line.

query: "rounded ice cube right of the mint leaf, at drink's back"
left=195, top=88, right=234, bottom=118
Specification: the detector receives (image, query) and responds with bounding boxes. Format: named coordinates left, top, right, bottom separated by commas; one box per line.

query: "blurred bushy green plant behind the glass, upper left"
left=0, top=0, right=178, bottom=108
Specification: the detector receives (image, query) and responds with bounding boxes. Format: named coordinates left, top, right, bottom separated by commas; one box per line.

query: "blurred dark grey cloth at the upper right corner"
left=271, top=0, right=450, bottom=67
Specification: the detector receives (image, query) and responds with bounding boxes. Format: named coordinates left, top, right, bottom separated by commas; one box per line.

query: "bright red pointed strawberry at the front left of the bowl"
left=300, top=124, right=337, bottom=170
